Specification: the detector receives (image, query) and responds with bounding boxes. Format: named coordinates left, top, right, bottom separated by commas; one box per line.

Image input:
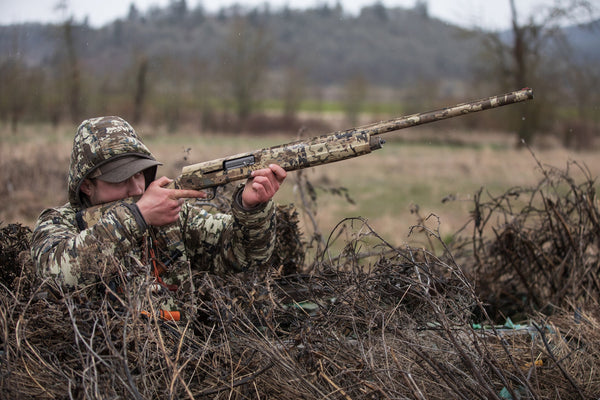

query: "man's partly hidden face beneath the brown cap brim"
left=81, top=172, right=146, bottom=206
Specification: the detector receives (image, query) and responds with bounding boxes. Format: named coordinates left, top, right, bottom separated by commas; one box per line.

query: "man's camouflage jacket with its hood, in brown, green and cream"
left=31, top=117, right=275, bottom=288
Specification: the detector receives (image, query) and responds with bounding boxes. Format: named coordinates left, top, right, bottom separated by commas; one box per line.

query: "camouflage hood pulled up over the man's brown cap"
left=67, top=117, right=156, bottom=208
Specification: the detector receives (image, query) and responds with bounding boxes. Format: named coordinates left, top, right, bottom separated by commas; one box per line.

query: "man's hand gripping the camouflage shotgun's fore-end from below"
left=242, top=164, right=287, bottom=208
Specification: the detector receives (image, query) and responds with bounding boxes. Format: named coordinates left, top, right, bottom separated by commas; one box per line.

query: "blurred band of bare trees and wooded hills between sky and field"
left=0, top=0, right=600, bottom=147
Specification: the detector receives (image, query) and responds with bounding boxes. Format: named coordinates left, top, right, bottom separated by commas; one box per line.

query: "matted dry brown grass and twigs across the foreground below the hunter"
left=0, top=199, right=600, bottom=400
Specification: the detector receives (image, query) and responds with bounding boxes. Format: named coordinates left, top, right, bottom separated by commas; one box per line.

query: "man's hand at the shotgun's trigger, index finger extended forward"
left=136, top=176, right=206, bottom=226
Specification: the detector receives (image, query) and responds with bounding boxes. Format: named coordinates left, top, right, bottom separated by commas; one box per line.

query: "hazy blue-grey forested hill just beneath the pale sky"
left=0, top=1, right=600, bottom=102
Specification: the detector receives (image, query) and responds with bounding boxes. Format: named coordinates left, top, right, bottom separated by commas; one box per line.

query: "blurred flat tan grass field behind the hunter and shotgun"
left=0, top=117, right=600, bottom=253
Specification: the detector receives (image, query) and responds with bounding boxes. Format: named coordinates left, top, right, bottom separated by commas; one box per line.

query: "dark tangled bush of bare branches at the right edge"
left=454, top=158, right=600, bottom=320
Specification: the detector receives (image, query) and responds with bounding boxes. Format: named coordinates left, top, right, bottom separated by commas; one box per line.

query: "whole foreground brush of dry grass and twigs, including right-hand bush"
left=0, top=161, right=600, bottom=399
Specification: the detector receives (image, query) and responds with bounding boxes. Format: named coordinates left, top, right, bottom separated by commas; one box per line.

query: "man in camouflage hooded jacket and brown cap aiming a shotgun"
left=31, top=117, right=286, bottom=304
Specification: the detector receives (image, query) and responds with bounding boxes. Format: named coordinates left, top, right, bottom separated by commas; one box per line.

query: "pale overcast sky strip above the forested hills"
left=0, top=0, right=600, bottom=29
